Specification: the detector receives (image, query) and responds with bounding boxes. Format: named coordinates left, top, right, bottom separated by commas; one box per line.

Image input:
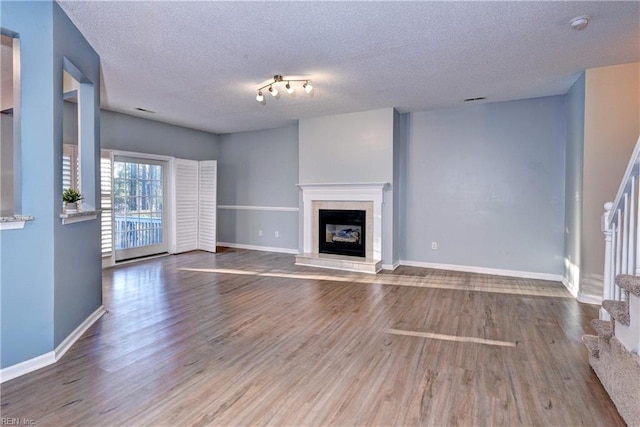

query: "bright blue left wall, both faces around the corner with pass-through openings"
left=0, top=2, right=102, bottom=368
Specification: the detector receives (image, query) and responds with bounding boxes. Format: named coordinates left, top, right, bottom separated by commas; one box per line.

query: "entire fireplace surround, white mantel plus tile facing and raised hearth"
left=296, top=183, right=387, bottom=274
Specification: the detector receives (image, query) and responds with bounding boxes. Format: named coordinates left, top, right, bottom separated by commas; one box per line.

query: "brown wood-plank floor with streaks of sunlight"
left=0, top=249, right=624, bottom=426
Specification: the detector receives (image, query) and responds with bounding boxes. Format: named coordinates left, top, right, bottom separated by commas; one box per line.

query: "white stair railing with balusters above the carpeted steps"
left=600, top=138, right=640, bottom=350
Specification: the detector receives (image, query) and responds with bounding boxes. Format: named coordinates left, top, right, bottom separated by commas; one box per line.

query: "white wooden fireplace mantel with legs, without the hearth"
left=298, top=182, right=389, bottom=260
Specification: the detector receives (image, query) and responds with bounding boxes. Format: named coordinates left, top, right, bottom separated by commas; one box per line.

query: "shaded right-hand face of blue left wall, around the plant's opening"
left=53, top=3, right=102, bottom=347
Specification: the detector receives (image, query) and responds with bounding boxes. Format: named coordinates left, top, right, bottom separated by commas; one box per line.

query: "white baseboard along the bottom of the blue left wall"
left=0, top=306, right=106, bottom=384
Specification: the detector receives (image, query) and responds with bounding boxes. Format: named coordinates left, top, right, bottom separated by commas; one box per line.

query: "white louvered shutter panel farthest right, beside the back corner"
left=198, top=160, right=218, bottom=252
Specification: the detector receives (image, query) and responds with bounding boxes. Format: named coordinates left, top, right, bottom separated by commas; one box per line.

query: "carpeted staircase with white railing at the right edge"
left=582, top=138, right=640, bottom=426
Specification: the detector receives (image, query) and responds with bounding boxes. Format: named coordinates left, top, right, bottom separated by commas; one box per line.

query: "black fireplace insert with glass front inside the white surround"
left=318, top=209, right=367, bottom=258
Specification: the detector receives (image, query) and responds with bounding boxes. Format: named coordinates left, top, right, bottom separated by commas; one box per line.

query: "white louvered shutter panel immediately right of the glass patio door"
left=174, top=159, right=198, bottom=253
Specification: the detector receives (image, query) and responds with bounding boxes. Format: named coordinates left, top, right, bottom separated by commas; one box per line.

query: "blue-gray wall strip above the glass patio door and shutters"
left=101, top=110, right=219, bottom=160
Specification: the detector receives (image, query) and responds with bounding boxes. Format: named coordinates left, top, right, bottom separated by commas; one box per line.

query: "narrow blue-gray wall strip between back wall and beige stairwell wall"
left=564, top=73, right=585, bottom=294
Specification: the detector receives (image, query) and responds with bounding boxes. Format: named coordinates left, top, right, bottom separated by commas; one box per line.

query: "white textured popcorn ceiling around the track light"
left=58, top=0, right=640, bottom=133
